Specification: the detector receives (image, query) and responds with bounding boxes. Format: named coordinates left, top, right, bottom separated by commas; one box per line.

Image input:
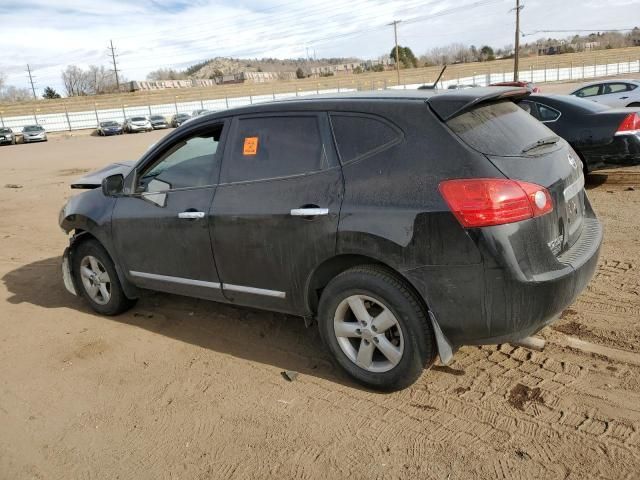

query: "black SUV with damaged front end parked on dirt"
left=60, top=87, right=602, bottom=389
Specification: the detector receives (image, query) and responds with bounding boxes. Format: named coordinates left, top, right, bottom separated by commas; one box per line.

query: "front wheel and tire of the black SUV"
left=73, top=240, right=136, bottom=315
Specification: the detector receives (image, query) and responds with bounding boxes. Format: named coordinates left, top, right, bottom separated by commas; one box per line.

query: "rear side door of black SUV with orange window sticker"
left=211, top=112, right=343, bottom=315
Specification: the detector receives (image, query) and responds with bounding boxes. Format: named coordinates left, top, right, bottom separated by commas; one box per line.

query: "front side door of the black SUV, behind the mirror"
left=112, top=122, right=226, bottom=300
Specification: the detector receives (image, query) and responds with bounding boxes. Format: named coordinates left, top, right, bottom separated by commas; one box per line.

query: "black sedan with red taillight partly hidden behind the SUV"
left=519, top=95, right=640, bottom=173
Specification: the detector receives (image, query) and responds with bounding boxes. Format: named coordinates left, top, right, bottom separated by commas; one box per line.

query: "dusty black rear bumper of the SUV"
left=404, top=216, right=603, bottom=347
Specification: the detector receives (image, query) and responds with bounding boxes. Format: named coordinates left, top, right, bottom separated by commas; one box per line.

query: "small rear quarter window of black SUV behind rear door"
left=331, top=114, right=400, bottom=163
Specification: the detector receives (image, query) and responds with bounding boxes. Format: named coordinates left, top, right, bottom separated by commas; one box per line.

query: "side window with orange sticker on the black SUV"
left=222, top=115, right=328, bottom=183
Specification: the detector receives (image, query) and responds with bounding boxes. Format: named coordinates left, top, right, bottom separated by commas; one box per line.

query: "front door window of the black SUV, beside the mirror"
left=137, top=125, right=222, bottom=193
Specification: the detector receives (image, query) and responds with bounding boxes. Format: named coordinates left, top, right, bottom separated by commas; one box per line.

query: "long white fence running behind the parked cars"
left=0, top=60, right=640, bottom=132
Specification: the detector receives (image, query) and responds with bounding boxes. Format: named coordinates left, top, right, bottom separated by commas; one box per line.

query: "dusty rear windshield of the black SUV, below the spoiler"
left=447, top=100, right=554, bottom=156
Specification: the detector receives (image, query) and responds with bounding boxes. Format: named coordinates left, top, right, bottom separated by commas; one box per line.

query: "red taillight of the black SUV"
left=440, top=178, right=553, bottom=228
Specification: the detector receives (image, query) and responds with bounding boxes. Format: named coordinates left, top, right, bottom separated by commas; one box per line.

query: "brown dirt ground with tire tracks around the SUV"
left=0, top=125, right=640, bottom=480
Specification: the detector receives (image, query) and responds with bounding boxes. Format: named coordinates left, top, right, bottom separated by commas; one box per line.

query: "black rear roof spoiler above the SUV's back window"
left=426, top=87, right=531, bottom=122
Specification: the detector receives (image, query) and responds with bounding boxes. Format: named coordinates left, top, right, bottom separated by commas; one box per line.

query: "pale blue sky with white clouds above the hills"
left=0, top=0, right=640, bottom=93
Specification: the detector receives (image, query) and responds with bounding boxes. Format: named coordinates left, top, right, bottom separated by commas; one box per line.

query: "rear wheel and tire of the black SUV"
left=318, top=265, right=436, bottom=391
